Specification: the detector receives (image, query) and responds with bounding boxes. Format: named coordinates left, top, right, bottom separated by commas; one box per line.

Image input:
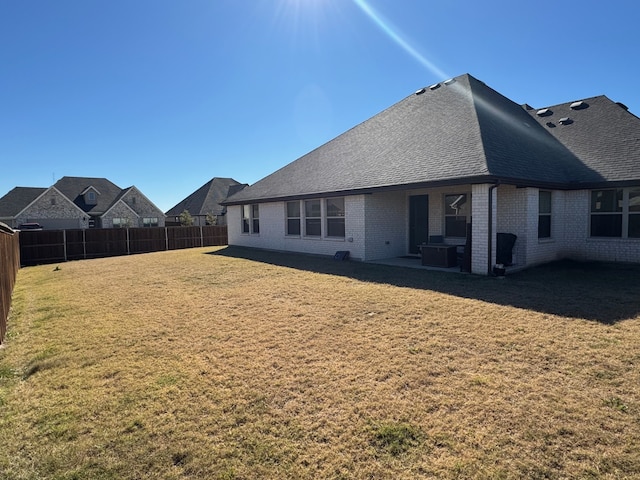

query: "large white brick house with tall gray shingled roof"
left=224, top=75, right=640, bottom=274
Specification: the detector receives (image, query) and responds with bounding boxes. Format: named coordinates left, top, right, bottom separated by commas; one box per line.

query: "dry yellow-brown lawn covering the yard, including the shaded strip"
left=0, top=247, right=640, bottom=479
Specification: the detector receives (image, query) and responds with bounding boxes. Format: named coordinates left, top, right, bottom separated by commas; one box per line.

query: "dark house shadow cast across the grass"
left=210, top=246, right=640, bottom=324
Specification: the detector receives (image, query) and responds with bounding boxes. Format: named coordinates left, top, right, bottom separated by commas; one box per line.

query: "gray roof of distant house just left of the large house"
left=165, top=177, right=245, bottom=216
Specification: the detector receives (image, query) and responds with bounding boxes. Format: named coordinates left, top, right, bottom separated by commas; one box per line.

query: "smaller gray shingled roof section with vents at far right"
left=529, top=95, right=640, bottom=184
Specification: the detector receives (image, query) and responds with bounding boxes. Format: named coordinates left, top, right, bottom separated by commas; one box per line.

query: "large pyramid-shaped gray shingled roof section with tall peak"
left=224, top=75, right=602, bottom=205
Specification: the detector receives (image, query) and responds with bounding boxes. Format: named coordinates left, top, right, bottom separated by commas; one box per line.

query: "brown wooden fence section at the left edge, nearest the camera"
left=0, top=223, right=20, bottom=343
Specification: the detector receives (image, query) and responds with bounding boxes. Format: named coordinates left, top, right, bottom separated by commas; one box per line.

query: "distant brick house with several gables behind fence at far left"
left=0, top=177, right=164, bottom=229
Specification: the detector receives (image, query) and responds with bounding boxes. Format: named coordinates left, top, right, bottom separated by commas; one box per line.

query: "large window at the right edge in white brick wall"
left=591, top=187, right=640, bottom=238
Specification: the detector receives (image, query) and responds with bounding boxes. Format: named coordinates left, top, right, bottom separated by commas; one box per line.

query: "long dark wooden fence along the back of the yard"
left=20, top=225, right=227, bottom=266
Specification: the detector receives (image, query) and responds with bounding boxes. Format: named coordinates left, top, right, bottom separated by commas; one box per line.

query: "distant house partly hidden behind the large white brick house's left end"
left=165, top=177, right=247, bottom=226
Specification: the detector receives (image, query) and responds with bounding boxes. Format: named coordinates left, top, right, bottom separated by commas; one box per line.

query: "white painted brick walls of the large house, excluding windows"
left=227, top=184, right=640, bottom=275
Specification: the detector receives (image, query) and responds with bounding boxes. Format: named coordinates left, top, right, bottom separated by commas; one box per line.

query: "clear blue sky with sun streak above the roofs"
left=0, top=0, right=640, bottom=211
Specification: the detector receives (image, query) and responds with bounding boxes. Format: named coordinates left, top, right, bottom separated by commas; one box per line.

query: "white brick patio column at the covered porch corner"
left=471, top=183, right=498, bottom=275
